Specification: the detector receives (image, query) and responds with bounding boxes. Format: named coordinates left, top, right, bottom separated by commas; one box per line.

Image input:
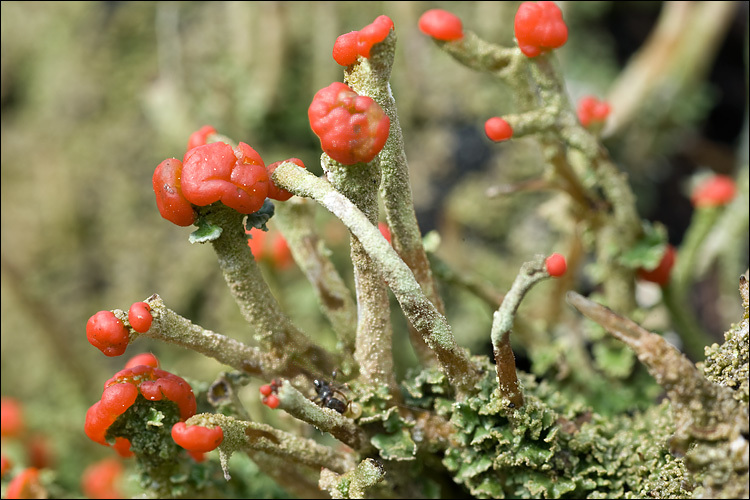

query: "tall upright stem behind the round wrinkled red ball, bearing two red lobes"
left=345, top=31, right=445, bottom=364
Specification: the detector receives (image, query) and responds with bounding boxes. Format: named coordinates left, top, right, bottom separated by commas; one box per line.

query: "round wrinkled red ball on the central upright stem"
left=307, top=82, right=391, bottom=165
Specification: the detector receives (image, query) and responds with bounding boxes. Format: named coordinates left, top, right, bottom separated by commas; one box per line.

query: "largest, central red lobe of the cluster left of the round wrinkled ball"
left=181, top=142, right=269, bottom=214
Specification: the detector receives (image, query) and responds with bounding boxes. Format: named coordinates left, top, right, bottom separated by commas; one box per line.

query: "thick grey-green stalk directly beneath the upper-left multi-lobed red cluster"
left=203, top=204, right=336, bottom=373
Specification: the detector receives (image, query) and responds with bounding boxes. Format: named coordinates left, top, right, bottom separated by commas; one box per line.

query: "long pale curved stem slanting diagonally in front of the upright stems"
left=273, top=162, right=481, bottom=393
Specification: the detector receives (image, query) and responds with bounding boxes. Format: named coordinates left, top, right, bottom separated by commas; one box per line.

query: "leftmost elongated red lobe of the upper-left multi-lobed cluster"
left=151, top=158, right=195, bottom=227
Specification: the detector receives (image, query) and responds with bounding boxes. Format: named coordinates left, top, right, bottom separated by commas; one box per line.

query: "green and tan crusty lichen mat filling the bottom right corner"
left=404, top=278, right=748, bottom=498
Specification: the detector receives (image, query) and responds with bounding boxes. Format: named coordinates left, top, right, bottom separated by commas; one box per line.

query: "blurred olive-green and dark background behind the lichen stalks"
left=0, top=1, right=748, bottom=496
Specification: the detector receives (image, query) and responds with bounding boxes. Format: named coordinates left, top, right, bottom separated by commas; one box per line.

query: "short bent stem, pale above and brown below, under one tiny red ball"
left=491, top=256, right=550, bottom=408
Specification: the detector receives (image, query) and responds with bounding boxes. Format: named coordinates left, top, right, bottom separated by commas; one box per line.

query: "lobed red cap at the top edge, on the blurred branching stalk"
left=514, top=2, right=568, bottom=57
